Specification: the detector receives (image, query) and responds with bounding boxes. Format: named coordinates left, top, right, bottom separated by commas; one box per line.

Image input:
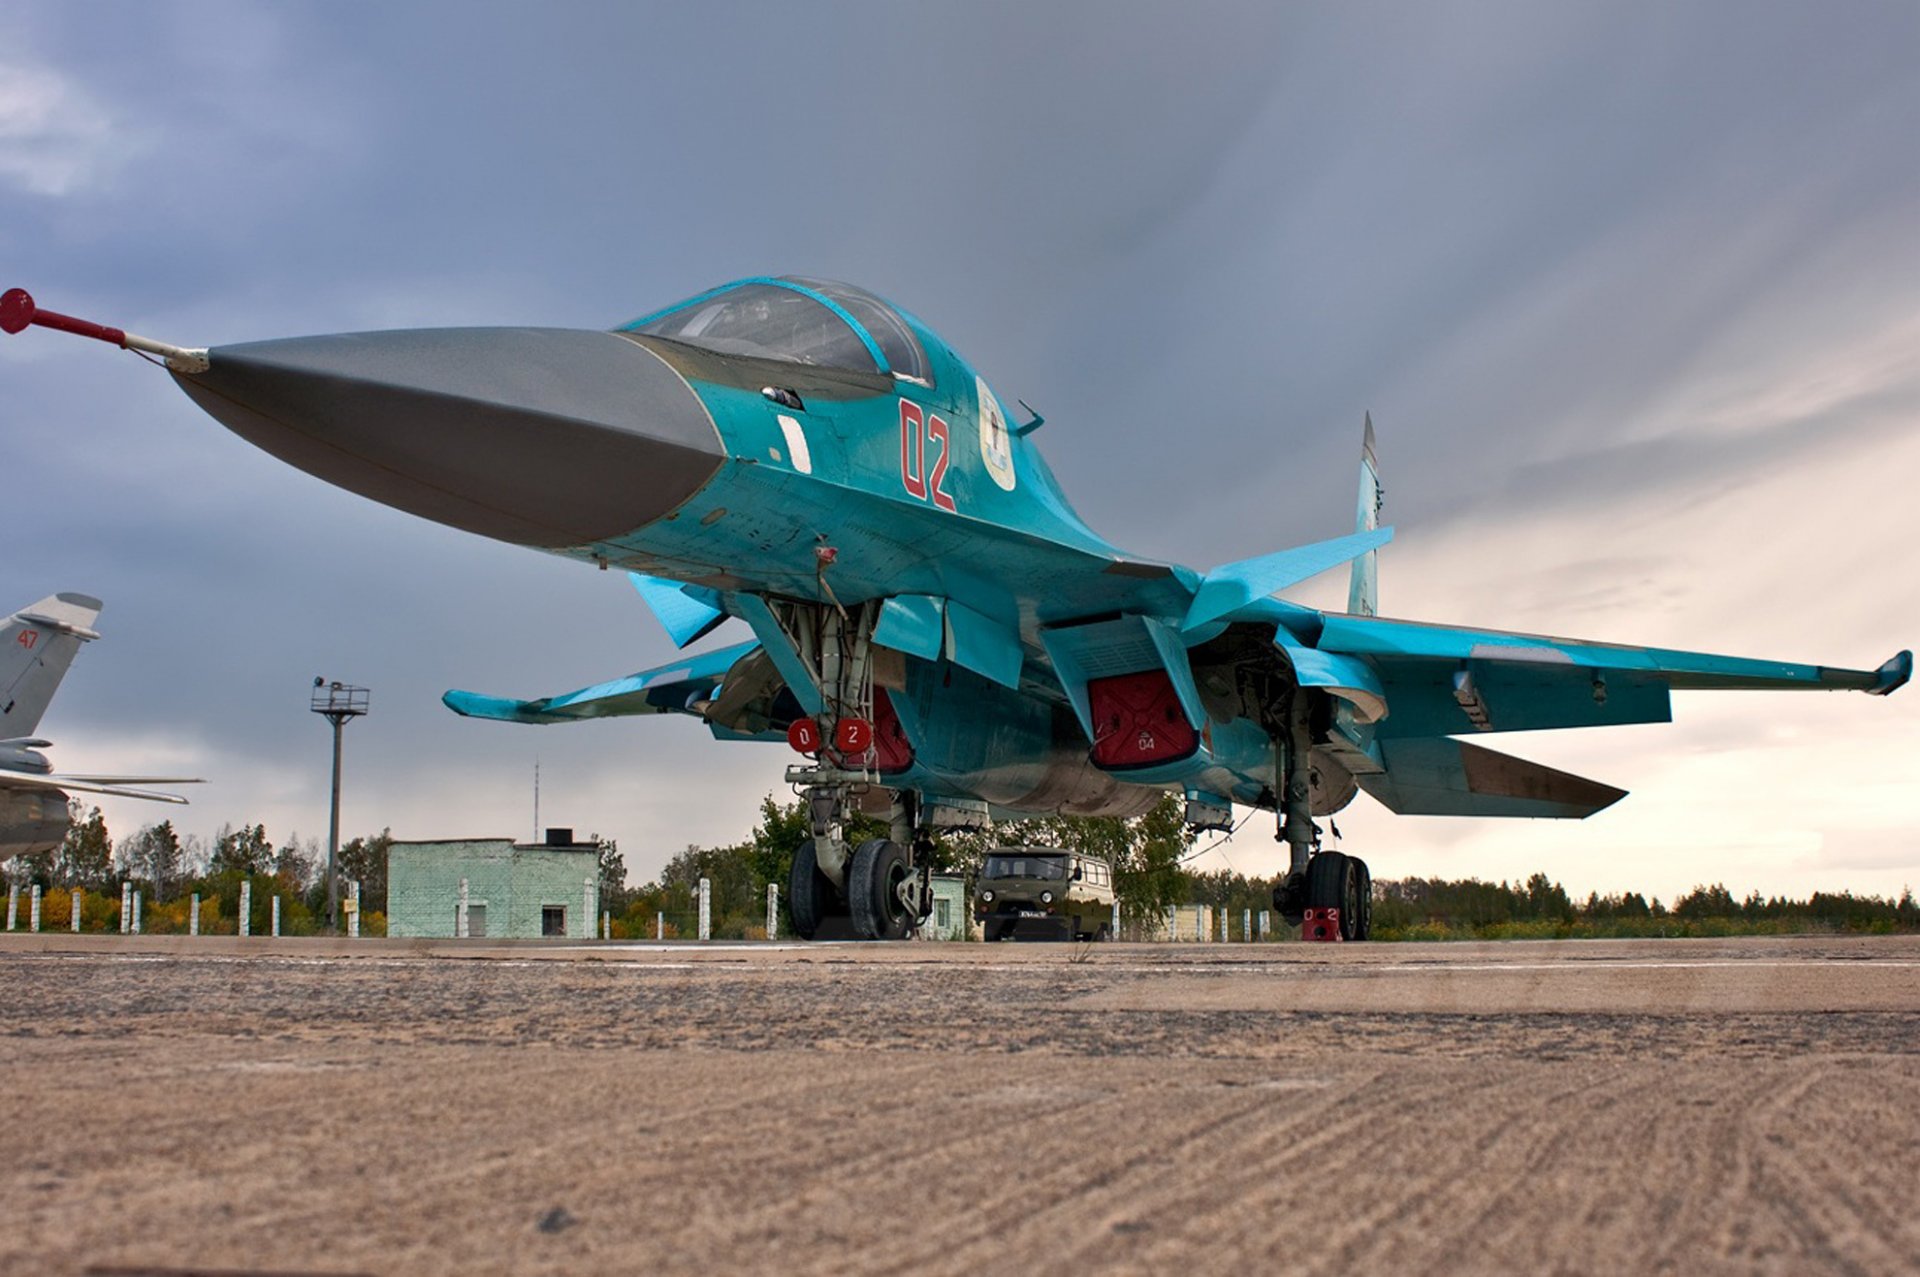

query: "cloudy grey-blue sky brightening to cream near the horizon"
left=0, top=0, right=1920, bottom=895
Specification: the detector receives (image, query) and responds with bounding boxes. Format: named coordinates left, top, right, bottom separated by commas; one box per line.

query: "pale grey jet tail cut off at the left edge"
left=0, top=593, right=200, bottom=862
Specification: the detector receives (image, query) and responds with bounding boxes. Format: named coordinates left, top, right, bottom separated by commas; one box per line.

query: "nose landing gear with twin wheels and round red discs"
left=774, top=603, right=933, bottom=941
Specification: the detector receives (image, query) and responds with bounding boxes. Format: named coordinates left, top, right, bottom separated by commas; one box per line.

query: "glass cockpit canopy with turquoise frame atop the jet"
left=626, top=275, right=933, bottom=384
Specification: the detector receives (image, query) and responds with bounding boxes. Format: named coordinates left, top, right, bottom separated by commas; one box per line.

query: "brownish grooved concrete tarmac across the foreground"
left=0, top=933, right=1920, bottom=1273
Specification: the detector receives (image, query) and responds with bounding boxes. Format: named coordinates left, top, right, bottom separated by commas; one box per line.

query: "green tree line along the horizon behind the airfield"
left=6, top=795, right=1920, bottom=941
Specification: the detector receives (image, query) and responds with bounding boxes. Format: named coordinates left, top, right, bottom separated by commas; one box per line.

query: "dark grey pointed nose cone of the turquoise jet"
left=175, top=328, right=722, bottom=549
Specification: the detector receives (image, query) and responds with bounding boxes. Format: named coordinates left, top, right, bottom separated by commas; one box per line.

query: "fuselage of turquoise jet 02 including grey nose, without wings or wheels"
left=177, top=278, right=1273, bottom=814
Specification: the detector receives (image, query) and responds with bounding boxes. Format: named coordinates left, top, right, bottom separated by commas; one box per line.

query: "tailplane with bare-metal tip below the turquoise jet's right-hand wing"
left=1356, top=737, right=1626, bottom=820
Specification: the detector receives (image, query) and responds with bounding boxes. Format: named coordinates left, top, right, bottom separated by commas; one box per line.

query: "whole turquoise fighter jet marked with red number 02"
left=0, top=277, right=1912, bottom=939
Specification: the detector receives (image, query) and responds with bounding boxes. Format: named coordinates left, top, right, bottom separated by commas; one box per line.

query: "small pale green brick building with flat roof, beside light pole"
left=386, top=830, right=599, bottom=939
